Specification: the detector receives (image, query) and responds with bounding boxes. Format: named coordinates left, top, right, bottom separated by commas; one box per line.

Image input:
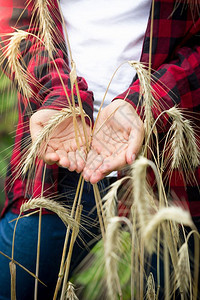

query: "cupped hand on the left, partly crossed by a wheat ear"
left=30, top=109, right=90, bottom=173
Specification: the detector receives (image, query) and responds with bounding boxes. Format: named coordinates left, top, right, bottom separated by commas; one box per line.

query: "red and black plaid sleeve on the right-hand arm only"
left=115, top=0, right=200, bottom=131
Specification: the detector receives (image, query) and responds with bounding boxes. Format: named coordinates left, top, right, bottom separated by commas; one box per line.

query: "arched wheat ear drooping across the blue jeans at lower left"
left=20, top=197, right=79, bottom=229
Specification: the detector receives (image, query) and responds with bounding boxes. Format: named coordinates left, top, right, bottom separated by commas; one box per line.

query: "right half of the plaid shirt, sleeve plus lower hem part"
left=114, top=0, right=200, bottom=220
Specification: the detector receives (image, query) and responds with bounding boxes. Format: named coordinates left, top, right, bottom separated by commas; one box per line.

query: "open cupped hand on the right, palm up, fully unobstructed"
left=83, top=100, right=144, bottom=184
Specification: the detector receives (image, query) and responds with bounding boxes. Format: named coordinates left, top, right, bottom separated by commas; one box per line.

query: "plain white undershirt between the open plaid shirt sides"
left=60, top=0, right=151, bottom=118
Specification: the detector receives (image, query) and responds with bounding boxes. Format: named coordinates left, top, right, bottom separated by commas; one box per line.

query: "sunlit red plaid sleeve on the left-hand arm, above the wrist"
left=0, top=0, right=93, bottom=120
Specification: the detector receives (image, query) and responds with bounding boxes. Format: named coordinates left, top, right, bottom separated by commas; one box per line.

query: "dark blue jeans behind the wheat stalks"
left=0, top=169, right=112, bottom=300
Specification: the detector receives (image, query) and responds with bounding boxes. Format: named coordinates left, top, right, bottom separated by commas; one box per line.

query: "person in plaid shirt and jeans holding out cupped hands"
left=0, top=0, right=200, bottom=299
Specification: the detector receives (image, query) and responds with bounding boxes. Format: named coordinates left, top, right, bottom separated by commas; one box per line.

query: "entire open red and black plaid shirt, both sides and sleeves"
left=0, top=0, right=200, bottom=216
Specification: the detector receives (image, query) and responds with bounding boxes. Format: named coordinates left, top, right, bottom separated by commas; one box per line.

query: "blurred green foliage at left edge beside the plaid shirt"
left=0, top=73, right=17, bottom=211
